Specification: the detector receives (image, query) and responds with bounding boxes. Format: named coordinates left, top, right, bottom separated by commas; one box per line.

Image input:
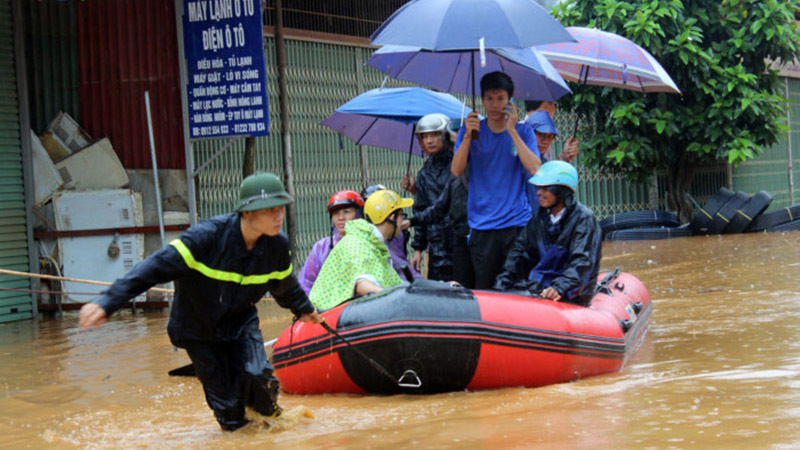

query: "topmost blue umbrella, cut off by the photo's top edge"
left=370, top=0, right=575, bottom=51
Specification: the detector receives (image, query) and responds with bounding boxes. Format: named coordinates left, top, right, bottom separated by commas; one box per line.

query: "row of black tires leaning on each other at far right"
left=689, top=188, right=800, bottom=235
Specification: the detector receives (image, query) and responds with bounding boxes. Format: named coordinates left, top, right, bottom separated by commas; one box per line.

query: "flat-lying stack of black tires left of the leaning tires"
left=600, top=210, right=692, bottom=241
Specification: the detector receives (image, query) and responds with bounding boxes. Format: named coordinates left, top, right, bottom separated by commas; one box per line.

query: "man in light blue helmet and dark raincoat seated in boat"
left=494, top=161, right=601, bottom=306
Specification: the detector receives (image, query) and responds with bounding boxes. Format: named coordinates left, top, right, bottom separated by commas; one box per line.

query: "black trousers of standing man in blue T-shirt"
left=469, top=227, right=524, bottom=289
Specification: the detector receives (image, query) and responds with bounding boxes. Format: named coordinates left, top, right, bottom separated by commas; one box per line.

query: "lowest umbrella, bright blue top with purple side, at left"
left=320, top=87, right=472, bottom=172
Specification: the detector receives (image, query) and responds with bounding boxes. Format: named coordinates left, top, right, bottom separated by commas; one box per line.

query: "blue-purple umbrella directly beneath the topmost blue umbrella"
left=367, top=45, right=571, bottom=101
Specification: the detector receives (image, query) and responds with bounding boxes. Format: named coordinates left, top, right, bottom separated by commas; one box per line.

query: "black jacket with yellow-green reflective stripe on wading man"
left=94, top=214, right=314, bottom=347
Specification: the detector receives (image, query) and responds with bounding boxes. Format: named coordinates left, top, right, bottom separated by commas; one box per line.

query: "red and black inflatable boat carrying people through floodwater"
left=272, top=273, right=652, bottom=394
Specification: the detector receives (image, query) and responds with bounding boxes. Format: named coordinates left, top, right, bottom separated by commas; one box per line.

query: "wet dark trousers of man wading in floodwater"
left=184, top=324, right=280, bottom=431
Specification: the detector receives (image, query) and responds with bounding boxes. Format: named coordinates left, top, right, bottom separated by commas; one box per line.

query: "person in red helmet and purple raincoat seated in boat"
left=297, top=190, right=364, bottom=294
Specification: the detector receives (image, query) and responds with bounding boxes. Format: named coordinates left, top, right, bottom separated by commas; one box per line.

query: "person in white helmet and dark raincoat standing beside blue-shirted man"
left=403, top=113, right=453, bottom=281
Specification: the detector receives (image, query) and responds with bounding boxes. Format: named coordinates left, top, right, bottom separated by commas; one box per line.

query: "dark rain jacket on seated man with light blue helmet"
left=495, top=196, right=602, bottom=305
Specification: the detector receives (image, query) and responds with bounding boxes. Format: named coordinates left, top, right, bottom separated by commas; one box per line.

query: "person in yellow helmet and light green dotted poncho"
left=309, top=190, right=414, bottom=310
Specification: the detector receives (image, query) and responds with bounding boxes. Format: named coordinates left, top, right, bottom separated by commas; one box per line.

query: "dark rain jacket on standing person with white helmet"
left=411, top=148, right=453, bottom=267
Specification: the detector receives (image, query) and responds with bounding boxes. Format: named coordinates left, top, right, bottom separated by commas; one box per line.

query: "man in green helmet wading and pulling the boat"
left=80, top=173, right=323, bottom=431
